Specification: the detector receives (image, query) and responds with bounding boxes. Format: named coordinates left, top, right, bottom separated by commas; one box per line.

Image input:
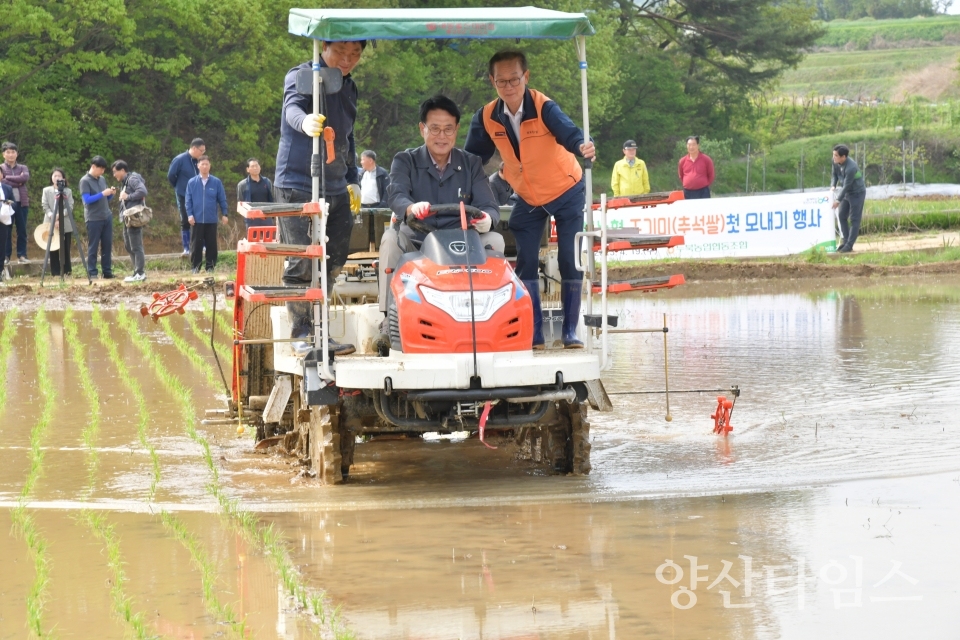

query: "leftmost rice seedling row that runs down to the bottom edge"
left=11, top=307, right=55, bottom=638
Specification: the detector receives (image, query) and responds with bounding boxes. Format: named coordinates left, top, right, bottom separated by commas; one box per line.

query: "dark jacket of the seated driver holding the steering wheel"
left=388, top=146, right=500, bottom=245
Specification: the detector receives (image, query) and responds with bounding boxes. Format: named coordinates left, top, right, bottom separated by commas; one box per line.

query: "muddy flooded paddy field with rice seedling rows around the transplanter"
left=0, top=275, right=960, bottom=639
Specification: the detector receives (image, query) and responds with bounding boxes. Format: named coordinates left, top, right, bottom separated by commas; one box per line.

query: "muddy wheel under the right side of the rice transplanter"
left=517, top=401, right=591, bottom=476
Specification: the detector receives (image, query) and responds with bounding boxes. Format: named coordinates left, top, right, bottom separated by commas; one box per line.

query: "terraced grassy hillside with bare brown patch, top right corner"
left=780, top=16, right=960, bottom=102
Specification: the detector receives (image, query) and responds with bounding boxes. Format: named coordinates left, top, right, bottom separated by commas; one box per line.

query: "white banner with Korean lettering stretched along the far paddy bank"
left=593, top=191, right=837, bottom=260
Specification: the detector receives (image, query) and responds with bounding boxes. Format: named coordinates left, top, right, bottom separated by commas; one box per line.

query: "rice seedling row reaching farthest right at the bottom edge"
left=119, top=307, right=353, bottom=640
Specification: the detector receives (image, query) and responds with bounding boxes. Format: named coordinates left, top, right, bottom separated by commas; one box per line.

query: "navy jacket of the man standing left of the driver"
left=273, top=60, right=360, bottom=196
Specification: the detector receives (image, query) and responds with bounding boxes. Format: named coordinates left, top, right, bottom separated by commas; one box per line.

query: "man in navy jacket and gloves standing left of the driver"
left=274, top=40, right=367, bottom=355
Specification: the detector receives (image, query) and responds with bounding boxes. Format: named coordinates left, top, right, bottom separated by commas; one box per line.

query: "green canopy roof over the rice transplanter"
left=288, top=7, right=595, bottom=41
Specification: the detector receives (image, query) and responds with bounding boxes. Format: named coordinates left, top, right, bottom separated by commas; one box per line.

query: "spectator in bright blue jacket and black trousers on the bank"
left=185, top=156, right=227, bottom=273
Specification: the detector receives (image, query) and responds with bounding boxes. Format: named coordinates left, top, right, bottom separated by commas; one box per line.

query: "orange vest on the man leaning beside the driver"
left=483, top=89, right=583, bottom=207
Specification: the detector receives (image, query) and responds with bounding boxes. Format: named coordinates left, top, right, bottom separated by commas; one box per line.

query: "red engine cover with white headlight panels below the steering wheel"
left=390, top=252, right=533, bottom=353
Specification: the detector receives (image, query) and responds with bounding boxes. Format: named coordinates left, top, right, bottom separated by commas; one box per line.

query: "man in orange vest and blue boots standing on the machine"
left=464, top=51, right=596, bottom=349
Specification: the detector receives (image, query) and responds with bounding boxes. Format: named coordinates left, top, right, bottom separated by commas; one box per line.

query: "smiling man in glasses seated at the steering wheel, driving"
left=380, top=95, right=504, bottom=313
